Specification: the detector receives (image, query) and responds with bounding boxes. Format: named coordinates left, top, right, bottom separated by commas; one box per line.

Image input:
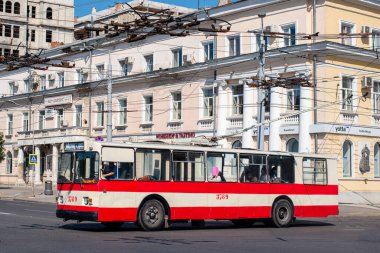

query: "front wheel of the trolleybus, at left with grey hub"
left=138, top=199, right=165, bottom=231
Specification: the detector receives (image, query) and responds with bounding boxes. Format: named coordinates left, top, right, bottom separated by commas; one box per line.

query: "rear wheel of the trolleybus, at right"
left=272, top=199, right=294, bottom=228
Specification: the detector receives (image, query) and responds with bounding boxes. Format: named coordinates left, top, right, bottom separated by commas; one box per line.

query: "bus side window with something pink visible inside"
left=207, top=152, right=238, bottom=182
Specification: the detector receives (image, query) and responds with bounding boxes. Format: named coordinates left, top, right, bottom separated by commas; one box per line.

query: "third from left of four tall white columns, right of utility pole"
left=269, top=87, right=283, bottom=151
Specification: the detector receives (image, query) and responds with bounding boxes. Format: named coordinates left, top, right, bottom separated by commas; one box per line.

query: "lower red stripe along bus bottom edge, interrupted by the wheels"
left=58, top=205, right=338, bottom=222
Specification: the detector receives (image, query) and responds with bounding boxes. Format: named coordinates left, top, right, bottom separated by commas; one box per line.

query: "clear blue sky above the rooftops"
left=74, top=0, right=218, bottom=17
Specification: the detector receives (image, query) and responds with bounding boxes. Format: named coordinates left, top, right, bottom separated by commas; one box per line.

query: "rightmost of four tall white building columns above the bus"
left=298, top=87, right=313, bottom=153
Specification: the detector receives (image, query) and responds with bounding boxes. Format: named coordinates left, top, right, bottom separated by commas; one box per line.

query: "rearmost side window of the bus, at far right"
left=302, top=157, right=327, bottom=185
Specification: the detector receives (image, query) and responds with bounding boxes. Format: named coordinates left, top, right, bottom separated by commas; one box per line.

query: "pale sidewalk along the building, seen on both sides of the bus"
left=0, top=185, right=380, bottom=217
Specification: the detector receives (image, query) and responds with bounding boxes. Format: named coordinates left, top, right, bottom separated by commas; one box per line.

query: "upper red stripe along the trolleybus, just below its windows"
left=57, top=181, right=338, bottom=195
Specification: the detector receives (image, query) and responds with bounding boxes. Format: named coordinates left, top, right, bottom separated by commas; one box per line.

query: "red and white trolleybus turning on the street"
left=56, top=141, right=338, bottom=231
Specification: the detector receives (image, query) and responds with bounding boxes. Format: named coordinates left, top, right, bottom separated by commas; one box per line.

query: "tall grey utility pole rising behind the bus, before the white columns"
left=257, top=13, right=266, bottom=150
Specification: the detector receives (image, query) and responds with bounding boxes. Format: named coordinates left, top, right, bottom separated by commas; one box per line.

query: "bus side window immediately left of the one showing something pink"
left=173, top=151, right=205, bottom=182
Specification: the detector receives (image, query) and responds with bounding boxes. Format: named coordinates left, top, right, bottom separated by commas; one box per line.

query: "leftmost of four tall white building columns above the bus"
left=216, top=81, right=228, bottom=147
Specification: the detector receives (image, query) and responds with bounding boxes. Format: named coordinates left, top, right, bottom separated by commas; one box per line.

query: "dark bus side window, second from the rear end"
left=268, top=155, right=294, bottom=183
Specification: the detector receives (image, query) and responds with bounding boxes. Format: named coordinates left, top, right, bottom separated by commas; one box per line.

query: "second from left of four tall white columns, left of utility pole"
left=242, top=83, right=255, bottom=148
